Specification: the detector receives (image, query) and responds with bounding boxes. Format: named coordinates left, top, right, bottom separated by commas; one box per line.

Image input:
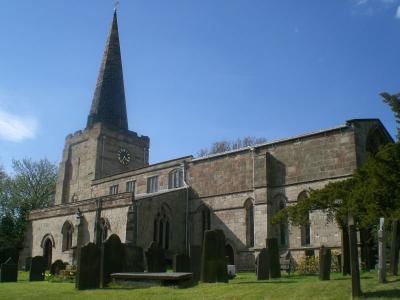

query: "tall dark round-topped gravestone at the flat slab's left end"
left=100, top=234, right=125, bottom=288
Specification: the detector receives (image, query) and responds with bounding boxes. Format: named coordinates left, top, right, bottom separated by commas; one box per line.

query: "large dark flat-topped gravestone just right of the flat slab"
left=201, top=230, right=228, bottom=282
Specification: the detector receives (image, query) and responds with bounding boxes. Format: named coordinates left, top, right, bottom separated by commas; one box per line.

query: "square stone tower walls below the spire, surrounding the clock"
left=55, top=124, right=149, bottom=204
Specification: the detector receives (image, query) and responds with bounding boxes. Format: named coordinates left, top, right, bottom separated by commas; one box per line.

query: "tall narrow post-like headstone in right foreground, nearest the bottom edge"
left=348, top=216, right=362, bottom=298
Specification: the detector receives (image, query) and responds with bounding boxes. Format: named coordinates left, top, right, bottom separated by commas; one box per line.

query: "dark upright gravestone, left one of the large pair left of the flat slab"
left=75, top=243, right=100, bottom=290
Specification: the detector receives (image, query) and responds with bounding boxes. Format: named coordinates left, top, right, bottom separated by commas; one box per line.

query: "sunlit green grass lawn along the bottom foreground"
left=0, top=272, right=400, bottom=300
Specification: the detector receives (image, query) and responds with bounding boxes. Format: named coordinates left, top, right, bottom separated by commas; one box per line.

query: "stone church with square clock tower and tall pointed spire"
left=20, top=12, right=392, bottom=270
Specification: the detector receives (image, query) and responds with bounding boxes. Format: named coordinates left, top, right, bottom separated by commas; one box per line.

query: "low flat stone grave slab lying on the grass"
left=111, top=272, right=193, bottom=287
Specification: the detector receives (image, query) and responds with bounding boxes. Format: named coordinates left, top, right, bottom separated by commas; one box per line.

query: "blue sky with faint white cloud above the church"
left=0, top=0, right=400, bottom=171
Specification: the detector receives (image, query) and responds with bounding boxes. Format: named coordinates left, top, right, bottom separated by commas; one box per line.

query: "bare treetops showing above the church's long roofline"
left=197, top=136, right=267, bottom=157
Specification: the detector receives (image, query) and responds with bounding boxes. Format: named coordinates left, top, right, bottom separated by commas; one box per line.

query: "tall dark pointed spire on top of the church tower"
left=86, top=10, right=128, bottom=130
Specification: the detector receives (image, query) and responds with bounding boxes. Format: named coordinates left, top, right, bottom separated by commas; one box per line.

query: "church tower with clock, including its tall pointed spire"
left=55, top=11, right=150, bottom=204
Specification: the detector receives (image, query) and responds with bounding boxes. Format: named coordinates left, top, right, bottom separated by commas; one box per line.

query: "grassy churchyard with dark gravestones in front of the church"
left=0, top=230, right=400, bottom=299
